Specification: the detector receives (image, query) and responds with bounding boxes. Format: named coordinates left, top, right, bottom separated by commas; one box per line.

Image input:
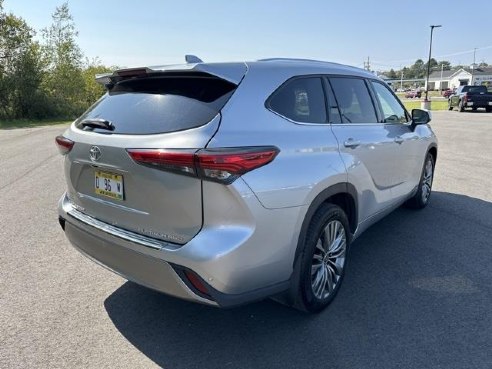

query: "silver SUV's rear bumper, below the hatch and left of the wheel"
left=59, top=188, right=298, bottom=307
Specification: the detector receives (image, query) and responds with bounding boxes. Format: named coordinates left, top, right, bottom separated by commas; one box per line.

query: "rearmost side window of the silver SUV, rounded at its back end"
left=267, top=77, right=327, bottom=123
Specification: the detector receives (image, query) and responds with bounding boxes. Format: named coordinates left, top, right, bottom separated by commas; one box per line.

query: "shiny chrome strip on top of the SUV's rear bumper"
left=67, top=209, right=179, bottom=250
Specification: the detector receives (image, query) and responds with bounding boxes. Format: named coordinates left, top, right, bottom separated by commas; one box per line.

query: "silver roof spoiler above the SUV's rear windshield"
left=95, top=56, right=248, bottom=89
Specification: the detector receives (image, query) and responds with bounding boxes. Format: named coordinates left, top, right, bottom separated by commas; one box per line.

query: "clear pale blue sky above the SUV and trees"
left=4, top=0, right=492, bottom=70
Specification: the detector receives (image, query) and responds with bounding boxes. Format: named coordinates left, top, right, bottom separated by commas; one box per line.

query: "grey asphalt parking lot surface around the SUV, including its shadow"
left=0, top=111, right=492, bottom=369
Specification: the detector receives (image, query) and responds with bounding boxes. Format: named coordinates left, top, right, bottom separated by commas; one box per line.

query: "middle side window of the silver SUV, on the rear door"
left=330, top=77, right=378, bottom=123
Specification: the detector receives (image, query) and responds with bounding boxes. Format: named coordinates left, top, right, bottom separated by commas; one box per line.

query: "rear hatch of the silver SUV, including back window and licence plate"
left=65, top=69, right=244, bottom=244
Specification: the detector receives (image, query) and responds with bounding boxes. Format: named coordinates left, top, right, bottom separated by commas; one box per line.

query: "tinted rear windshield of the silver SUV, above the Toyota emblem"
left=75, top=76, right=237, bottom=134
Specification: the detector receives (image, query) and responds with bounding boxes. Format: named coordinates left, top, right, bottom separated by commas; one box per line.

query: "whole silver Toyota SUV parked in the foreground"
left=56, top=59, right=437, bottom=312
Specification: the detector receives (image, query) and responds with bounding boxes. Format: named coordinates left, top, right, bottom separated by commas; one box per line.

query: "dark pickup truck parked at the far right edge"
left=448, top=86, right=492, bottom=113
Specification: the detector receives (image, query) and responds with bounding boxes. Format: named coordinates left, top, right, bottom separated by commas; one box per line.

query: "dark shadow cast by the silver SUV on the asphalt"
left=104, top=192, right=492, bottom=368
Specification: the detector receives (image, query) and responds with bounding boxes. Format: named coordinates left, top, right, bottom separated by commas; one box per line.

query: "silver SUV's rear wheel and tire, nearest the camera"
left=291, top=204, right=351, bottom=313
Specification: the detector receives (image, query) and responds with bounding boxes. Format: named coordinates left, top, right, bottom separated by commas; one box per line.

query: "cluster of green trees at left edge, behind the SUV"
left=0, top=0, right=114, bottom=119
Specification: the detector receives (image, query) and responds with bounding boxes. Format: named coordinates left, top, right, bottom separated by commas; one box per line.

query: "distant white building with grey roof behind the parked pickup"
left=429, top=67, right=492, bottom=90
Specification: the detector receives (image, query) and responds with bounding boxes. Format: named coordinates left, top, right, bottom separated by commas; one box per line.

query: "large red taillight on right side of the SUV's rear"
left=127, top=146, right=279, bottom=184
